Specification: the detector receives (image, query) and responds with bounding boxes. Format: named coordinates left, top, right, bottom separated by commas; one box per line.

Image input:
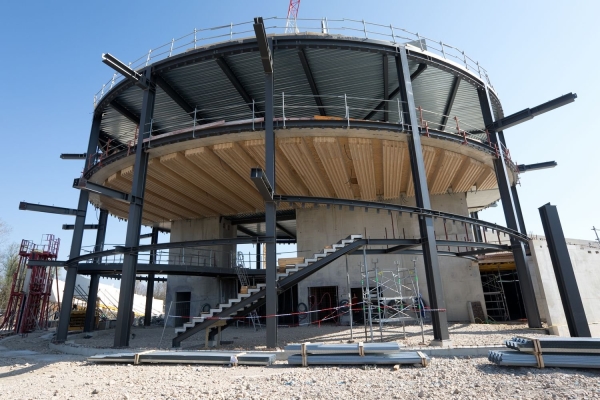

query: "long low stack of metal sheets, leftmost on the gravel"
left=88, top=351, right=275, bottom=365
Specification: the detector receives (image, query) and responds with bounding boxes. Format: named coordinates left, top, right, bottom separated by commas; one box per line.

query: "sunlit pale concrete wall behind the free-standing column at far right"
left=530, top=236, right=600, bottom=337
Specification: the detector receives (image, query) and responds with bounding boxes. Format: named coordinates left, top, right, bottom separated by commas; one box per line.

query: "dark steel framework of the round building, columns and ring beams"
left=21, top=16, right=576, bottom=347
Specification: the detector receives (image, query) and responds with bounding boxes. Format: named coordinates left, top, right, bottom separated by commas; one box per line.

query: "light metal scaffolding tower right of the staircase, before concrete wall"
left=360, top=260, right=425, bottom=342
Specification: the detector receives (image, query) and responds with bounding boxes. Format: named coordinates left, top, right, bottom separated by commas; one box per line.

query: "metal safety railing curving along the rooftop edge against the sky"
left=94, top=17, right=493, bottom=107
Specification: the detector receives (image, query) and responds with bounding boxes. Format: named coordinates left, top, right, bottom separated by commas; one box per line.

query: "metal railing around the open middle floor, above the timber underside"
left=87, top=92, right=516, bottom=171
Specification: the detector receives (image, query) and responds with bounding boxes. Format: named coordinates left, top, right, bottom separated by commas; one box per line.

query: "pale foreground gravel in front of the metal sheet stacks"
left=0, top=348, right=600, bottom=400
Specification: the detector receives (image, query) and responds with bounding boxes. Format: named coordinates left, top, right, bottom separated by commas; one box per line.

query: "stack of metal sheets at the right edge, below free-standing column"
left=488, top=337, right=600, bottom=368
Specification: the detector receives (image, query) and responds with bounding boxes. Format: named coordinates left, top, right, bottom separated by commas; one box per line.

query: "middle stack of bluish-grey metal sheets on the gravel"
left=285, top=343, right=429, bottom=366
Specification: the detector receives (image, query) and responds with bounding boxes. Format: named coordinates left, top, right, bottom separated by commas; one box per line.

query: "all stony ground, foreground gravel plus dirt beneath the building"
left=0, top=324, right=600, bottom=400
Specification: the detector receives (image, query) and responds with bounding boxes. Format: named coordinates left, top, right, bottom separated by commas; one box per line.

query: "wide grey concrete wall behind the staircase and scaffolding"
left=296, top=194, right=485, bottom=321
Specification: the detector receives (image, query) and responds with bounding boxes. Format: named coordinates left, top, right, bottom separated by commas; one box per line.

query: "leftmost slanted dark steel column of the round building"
left=56, top=113, right=102, bottom=343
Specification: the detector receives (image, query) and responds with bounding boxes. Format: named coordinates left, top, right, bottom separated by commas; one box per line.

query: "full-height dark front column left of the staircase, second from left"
left=114, top=67, right=156, bottom=347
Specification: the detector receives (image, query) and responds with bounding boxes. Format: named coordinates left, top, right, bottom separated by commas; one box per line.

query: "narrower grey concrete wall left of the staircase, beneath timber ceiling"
left=165, top=217, right=237, bottom=326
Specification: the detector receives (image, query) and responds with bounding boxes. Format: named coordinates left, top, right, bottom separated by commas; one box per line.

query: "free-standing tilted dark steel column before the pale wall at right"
left=539, top=203, right=592, bottom=337
